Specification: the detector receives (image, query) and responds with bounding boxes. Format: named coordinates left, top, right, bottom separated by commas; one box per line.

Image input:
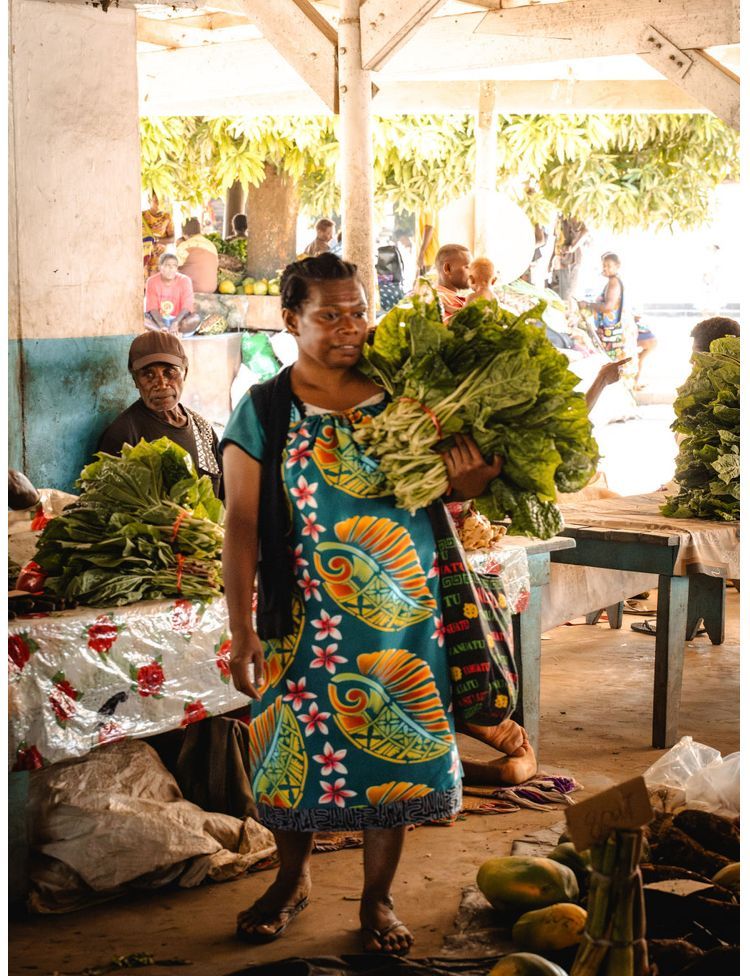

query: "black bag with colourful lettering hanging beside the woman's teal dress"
left=429, top=502, right=518, bottom=731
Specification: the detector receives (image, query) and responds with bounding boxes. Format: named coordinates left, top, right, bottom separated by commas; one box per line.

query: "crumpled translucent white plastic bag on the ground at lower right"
left=643, top=735, right=740, bottom=817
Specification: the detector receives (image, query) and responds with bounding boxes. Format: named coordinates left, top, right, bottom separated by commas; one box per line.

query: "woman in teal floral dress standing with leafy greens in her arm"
left=222, top=254, right=522, bottom=954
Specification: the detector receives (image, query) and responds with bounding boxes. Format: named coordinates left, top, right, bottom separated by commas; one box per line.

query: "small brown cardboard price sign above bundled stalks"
left=565, top=776, right=654, bottom=851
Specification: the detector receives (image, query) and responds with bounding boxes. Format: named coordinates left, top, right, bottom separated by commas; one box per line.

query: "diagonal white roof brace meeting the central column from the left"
left=232, top=0, right=338, bottom=112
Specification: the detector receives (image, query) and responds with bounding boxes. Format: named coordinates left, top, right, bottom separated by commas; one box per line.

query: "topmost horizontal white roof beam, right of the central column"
left=387, top=0, right=739, bottom=77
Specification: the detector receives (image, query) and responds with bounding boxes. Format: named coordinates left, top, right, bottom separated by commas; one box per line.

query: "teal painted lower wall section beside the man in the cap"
left=8, top=335, right=138, bottom=491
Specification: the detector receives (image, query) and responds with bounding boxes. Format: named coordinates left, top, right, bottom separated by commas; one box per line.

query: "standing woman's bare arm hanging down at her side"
left=222, top=444, right=263, bottom=700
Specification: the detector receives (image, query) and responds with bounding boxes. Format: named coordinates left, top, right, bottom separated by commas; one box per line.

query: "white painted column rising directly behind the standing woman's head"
left=339, top=0, right=377, bottom=321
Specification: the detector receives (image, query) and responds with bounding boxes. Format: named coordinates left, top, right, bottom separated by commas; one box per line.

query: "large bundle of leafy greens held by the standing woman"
left=355, top=296, right=599, bottom=539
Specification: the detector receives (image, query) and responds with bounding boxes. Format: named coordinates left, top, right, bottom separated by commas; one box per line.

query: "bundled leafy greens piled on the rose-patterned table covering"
left=34, top=437, right=224, bottom=607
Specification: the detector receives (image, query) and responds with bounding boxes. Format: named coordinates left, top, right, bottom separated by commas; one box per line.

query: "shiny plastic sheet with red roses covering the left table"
left=8, top=598, right=247, bottom=769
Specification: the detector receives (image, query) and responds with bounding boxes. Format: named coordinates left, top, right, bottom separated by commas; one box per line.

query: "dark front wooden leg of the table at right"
left=651, top=576, right=689, bottom=749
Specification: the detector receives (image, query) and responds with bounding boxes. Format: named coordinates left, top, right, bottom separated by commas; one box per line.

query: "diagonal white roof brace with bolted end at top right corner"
left=641, top=27, right=740, bottom=129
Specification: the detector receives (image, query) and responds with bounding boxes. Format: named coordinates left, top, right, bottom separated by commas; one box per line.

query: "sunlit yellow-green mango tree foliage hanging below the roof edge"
left=141, top=113, right=739, bottom=231
